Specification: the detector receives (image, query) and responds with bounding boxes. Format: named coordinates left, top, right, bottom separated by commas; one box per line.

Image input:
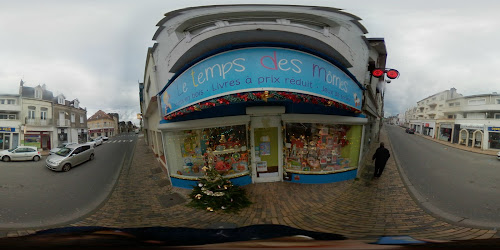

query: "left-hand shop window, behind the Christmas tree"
left=165, top=125, right=249, bottom=177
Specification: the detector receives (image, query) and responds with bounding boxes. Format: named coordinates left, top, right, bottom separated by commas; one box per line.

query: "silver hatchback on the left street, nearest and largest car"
left=45, top=144, right=94, bottom=172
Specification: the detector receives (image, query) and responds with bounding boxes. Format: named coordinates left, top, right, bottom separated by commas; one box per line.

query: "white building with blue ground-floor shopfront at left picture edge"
left=0, top=94, right=22, bottom=150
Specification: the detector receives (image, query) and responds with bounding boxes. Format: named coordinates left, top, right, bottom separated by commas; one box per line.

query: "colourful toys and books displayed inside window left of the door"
left=177, top=125, right=248, bottom=176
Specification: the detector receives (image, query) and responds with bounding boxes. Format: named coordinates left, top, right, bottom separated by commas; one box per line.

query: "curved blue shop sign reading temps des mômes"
left=160, top=48, right=362, bottom=116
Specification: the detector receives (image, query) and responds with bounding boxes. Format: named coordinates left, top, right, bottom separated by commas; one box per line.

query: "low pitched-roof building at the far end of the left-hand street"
left=87, top=110, right=118, bottom=138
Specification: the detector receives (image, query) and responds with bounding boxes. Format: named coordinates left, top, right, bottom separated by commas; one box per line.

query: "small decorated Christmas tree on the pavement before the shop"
left=188, top=167, right=252, bottom=213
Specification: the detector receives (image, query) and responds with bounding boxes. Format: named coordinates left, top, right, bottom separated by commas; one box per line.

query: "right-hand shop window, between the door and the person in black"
left=284, top=123, right=362, bottom=174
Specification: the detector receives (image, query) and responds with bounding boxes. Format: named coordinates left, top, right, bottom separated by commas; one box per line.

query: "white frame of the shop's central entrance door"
left=250, top=115, right=283, bottom=183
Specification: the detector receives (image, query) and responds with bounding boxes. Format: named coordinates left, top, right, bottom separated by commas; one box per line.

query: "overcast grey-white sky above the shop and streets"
left=0, top=0, right=500, bottom=121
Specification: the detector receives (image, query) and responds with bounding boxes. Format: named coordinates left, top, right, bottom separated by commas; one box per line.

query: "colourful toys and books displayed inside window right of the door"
left=284, top=123, right=351, bottom=172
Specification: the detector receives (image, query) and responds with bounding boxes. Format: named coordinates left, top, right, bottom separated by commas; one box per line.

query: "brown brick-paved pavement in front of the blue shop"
left=1, top=130, right=498, bottom=241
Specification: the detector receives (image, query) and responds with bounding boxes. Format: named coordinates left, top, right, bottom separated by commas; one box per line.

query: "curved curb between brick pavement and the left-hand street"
left=0, top=137, right=139, bottom=235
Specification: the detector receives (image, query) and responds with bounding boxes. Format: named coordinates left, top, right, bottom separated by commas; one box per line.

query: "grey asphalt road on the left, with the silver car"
left=0, top=133, right=137, bottom=229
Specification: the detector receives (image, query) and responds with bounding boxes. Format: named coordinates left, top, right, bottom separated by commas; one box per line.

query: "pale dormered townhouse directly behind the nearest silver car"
left=53, top=94, right=88, bottom=145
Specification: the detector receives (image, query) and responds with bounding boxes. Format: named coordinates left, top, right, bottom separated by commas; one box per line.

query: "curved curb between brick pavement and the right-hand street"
left=383, top=125, right=500, bottom=230
